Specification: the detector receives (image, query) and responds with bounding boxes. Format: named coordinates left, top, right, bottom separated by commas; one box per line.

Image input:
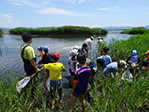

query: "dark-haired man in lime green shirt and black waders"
left=20, top=33, right=40, bottom=76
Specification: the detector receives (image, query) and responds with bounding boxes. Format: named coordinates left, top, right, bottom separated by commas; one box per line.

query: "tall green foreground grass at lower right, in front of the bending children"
left=90, top=74, right=149, bottom=112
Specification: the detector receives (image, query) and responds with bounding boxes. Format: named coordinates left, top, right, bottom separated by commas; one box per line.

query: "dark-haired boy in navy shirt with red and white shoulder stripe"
left=71, top=53, right=91, bottom=112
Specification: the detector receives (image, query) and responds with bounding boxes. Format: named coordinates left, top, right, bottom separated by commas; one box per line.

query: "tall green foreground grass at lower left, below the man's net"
left=0, top=72, right=65, bottom=112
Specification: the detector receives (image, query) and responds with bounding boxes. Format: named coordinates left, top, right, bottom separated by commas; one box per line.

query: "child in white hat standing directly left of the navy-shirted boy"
left=68, top=50, right=77, bottom=88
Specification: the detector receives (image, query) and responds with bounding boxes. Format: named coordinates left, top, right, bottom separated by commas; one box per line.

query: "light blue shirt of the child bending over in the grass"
left=103, top=62, right=118, bottom=76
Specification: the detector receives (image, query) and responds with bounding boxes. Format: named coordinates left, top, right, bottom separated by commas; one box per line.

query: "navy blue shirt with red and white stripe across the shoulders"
left=74, top=66, right=91, bottom=94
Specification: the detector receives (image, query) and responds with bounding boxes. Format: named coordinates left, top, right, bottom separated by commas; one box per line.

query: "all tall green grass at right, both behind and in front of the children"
left=89, top=34, right=149, bottom=112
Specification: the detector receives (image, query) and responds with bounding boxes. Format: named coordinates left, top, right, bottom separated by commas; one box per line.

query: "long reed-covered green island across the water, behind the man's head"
left=9, top=26, right=108, bottom=35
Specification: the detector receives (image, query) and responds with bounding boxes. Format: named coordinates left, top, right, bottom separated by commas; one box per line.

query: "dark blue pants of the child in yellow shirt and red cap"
left=50, top=79, right=62, bottom=99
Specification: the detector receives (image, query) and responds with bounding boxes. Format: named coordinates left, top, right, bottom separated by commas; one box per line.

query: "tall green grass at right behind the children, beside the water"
left=109, top=34, right=149, bottom=62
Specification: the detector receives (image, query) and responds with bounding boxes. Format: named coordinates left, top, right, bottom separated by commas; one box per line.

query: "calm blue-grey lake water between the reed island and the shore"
left=0, top=31, right=130, bottom=78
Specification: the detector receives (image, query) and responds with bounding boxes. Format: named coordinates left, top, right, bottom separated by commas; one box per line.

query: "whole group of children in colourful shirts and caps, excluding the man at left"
left=35, top=38, right=149, bottom=112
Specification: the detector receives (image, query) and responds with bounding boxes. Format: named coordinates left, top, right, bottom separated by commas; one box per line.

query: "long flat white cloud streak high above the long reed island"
left=35, top=7, right=85, bottom=16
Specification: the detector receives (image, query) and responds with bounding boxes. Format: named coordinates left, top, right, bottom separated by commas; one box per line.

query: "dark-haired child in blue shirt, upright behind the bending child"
left=100, top=47, right=112, bottom=66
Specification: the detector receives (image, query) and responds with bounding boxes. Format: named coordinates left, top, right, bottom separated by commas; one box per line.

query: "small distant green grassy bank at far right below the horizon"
left=121, top=27, right=149, bottom=34
